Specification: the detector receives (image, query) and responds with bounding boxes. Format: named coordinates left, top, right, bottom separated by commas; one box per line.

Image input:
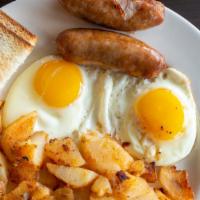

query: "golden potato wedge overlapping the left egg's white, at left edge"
left=1, top=112, right=37, bottom=161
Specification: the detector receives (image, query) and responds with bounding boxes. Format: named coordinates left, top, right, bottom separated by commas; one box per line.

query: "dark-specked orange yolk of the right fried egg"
left=135, top=88, right=184, bottom=140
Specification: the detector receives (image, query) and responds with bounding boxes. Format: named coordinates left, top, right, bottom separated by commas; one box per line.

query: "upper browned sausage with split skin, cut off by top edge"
left=59, top=0, right=165, bottom=31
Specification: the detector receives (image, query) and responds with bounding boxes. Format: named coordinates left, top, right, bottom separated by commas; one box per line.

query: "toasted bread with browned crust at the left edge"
left=0, top=10, right=37, bottom=90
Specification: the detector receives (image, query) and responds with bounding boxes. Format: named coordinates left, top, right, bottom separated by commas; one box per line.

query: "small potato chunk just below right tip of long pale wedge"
left=91, top=176, right=112, bottom=197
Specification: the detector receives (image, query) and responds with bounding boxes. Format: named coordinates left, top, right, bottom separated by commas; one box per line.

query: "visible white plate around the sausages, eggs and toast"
left=2, top=0, right=200, bottom=199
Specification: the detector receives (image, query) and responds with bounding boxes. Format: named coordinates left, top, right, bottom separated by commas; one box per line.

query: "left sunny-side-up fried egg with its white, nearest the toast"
left=3, top=56, right=100, bottom=138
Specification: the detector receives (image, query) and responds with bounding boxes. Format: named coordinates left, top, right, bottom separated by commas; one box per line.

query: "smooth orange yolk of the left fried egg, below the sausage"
left=34, top=60, right=82, bottom=108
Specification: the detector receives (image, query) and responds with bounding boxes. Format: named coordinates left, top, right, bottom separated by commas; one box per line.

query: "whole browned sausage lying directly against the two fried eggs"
left=57, top=29, right=167, bottom=78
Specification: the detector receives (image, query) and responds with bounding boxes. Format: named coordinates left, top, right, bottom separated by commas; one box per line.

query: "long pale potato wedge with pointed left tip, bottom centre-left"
left=47, top=163, right=97, bottom=188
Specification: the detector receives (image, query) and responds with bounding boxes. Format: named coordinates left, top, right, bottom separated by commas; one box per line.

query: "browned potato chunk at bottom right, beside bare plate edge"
left=159, top=166, right=194, bottom=200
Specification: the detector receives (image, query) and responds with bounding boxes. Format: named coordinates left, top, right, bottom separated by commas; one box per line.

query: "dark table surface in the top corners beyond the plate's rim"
left=0, top=0, right=200, bottom=29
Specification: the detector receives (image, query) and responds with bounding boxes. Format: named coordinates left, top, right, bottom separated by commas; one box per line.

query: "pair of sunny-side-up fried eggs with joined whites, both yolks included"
left=3, top=56, right=196, bottom=165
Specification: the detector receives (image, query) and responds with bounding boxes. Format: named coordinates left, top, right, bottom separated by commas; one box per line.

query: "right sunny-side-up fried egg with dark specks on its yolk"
left=106, top=68, right=197, bottom=165
